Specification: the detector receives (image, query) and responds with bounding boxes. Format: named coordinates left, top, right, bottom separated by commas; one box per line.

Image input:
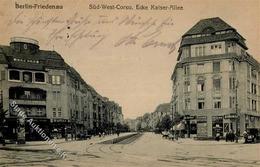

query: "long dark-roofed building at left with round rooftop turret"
left=0, top=37, right=122, bottom=139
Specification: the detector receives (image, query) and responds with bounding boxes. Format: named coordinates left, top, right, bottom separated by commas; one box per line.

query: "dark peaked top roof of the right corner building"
left=183, top=17, right=235, bottom=36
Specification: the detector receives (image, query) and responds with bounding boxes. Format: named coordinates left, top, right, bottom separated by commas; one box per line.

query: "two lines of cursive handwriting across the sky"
left=7, top=12, right=180, bottom=54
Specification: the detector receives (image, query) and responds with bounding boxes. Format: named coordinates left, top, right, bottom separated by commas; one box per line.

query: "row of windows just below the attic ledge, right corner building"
left=184, top=61, right=235, bottom=75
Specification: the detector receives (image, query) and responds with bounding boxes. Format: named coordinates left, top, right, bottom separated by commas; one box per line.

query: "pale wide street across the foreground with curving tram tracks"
left=0, top=133, right=260, bottom=167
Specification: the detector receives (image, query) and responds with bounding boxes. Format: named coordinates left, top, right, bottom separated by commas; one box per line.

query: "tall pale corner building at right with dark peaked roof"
left=171, top=17, right=260, bottom=137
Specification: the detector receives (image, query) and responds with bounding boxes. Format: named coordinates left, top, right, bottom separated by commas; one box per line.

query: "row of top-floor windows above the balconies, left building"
left=9, top=70, right=62, bottom=85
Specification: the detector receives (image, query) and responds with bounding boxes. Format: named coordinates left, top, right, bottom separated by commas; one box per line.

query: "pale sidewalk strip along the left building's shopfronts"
left=0, top=133, right=131, bottom=152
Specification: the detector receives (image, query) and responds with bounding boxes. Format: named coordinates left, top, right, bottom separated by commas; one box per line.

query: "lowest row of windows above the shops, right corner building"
left=184, top=96, right=257, bottom=111
